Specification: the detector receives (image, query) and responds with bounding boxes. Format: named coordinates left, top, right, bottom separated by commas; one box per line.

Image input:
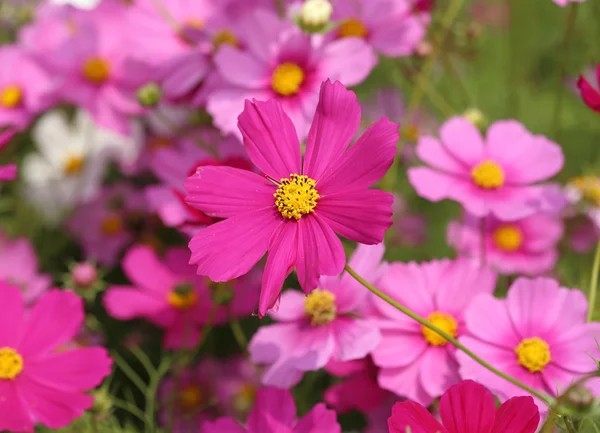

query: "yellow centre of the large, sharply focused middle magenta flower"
left=273, top=173, right=321, bottom=221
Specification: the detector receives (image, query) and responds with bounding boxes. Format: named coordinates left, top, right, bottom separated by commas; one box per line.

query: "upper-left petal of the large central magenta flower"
left=238, top=99, right=302, bottom=181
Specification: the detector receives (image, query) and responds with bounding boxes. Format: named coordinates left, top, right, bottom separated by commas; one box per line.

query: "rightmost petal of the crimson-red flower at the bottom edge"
left=492, top=397, right=540, bottom=433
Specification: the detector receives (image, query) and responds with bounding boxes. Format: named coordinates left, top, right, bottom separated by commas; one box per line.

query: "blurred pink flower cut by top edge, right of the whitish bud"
left=332, top=0, right=431, bottom=57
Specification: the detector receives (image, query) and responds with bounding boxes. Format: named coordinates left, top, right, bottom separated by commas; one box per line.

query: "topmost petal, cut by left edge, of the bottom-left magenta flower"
left=0, top=281, right=24, bottom=347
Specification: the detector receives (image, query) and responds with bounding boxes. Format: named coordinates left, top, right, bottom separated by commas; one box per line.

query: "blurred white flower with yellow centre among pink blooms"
left=22, top=111, right=110, bottom=223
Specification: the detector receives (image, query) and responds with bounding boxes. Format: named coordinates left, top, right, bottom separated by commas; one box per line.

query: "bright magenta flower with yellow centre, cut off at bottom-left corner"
left=0, top=282, right=112, bottom=433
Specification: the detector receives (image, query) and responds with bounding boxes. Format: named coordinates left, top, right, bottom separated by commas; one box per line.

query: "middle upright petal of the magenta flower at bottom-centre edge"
left=248, top=387, right=296, bottom=433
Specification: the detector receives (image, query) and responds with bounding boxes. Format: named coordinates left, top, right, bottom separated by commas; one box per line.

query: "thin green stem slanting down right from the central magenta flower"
left=344, top=264, right=550, bottom=406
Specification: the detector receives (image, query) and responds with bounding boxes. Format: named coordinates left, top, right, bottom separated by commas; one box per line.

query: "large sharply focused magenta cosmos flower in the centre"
left=185, top=80, right=398, bottom=316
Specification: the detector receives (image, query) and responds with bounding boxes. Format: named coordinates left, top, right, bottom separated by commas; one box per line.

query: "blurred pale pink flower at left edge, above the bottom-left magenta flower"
left=0, top=235, right=52, bottom=305
